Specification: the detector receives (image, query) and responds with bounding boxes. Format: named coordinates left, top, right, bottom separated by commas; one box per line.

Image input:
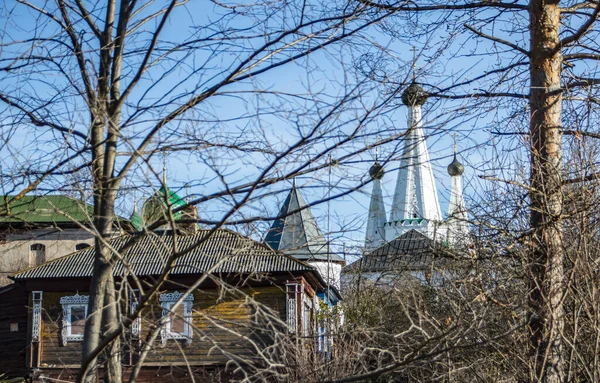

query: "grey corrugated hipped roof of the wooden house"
left=13, top=229, right=314, bottom=280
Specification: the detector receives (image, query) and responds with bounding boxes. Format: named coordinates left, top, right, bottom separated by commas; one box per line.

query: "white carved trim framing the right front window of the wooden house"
left=159, top=291, right=194, bottom=346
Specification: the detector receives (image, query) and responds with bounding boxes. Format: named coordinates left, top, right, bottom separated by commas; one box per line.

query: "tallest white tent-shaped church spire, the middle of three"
left=388, top=76, right=442, bottom=230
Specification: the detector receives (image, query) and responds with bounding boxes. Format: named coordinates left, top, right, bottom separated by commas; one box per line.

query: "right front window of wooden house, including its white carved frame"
left=160, top=291, right=194, bottom=345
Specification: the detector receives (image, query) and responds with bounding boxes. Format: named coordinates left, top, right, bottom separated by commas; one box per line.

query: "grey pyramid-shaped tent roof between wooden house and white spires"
left=265, top=183, right=344, bottom=262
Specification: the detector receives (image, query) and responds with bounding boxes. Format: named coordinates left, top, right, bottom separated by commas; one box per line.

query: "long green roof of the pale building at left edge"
left=0, top=195, right=94, bottom=225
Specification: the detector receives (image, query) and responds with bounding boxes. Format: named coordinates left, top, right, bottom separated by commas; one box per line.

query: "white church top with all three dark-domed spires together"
left=365, top=79, right=470, bottom=253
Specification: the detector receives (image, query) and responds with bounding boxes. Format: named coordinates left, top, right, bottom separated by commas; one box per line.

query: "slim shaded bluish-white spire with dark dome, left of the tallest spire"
left=365, top=160, right=386, bottom=252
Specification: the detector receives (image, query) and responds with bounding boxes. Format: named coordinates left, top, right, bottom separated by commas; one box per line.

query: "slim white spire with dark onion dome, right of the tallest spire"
left=446, top=134, right=469, bottom=244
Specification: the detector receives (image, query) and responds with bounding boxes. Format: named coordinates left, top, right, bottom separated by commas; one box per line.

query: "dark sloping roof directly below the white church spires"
left=344, top=230, right=436, bottom=273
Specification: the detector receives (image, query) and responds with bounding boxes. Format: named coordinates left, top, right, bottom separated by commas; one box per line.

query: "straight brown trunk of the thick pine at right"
left=528, top=0, right=564, bottom=383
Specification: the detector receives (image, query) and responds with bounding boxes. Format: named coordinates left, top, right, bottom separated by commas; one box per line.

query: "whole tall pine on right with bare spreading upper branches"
left=336, top=0, right=600, bottom=382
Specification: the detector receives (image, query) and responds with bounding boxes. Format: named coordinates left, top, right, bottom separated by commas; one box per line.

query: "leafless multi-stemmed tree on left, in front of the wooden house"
left=0, top=0, right=404, bottom=382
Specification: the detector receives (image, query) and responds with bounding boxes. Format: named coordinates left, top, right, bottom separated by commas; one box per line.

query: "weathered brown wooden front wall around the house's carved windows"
left=39, top=286, right=286, bottom=382
